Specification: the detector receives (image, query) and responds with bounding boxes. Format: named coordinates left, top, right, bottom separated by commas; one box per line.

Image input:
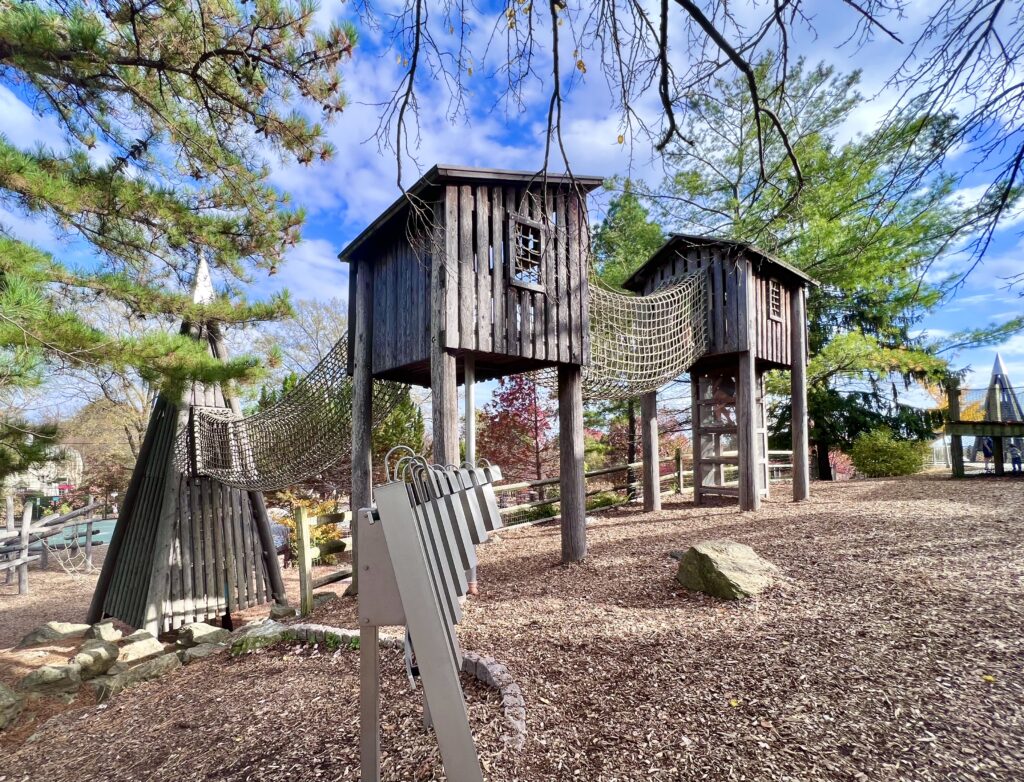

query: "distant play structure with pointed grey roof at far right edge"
left=945, top=354, right=1024, bottom=478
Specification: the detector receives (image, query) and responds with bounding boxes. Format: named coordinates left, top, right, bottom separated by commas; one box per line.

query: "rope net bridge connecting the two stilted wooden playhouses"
left=538, top=270, right=710, bottom=401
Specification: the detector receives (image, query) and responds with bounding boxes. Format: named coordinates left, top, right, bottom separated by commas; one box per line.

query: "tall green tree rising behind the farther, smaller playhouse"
left=660, top=57, right=1024, bottom=477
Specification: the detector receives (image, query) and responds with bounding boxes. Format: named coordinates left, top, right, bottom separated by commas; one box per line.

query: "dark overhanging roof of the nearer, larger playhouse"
left=338, top=163, right=604, bottom=262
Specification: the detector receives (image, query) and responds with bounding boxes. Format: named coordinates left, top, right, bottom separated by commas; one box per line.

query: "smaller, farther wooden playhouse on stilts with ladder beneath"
left=624, top=233, right=814, bottom=510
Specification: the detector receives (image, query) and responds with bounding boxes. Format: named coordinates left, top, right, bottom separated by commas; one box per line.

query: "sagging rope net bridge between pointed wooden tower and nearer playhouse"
left=175, top=338, right=406, bottom=491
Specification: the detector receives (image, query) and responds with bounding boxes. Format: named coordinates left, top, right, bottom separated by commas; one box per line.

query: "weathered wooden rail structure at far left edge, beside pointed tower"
left=0, top=496, right=103, bottom=595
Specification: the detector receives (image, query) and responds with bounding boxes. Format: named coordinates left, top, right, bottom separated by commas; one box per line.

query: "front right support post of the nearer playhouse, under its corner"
left=558, top=364, right=587, bottom=563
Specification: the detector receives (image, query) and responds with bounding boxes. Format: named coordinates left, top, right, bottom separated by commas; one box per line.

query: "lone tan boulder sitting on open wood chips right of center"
left=676, top=540, right=778, bottom=600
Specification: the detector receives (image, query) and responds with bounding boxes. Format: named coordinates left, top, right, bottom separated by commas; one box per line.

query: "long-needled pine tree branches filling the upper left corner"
left=0, top=0, right=355, bottom=466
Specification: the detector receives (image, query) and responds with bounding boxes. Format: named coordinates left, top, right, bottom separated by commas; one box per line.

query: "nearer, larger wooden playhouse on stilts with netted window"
left=340, top=165, right=602, bottom=559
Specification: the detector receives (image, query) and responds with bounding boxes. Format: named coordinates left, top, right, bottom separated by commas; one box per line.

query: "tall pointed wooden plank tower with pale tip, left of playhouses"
left=88, top=261, right=286, bottom=635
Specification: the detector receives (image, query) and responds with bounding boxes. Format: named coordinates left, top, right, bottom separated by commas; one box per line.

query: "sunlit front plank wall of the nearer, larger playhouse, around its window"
left=438, top=184, right=590, bottom=370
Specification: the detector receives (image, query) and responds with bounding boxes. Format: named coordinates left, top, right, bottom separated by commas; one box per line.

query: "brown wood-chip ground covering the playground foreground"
left=0, top=476, right=1024, bottom=782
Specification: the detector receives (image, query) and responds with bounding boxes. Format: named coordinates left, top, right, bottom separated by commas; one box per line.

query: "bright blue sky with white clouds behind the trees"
left=0, top=0, right=1024, bottom=405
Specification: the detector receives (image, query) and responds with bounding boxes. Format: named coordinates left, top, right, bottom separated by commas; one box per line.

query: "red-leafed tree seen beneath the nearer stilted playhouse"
left=477, top=375, right=558, bottom=480
